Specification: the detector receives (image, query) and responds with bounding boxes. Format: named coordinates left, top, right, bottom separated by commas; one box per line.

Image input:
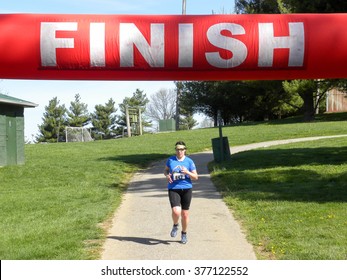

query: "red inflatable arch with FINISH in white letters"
left=0, top=14, right=347, bottom=80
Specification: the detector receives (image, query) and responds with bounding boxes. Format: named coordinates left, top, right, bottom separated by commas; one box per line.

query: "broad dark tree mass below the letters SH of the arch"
left=180, top=81, right=298, bottom=125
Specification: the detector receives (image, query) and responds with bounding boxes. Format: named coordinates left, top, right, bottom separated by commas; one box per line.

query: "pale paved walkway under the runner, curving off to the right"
left=102, top=135, right=347, bottom=260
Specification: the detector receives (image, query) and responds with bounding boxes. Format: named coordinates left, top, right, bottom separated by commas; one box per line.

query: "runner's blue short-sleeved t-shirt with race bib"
left=166, top=156, right=196, bottom=190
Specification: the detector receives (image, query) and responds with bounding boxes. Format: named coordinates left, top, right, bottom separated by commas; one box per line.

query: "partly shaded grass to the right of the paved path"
left=211, top=137, right=347, bottom=260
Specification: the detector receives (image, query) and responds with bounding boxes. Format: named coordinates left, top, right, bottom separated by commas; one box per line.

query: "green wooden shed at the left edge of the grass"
left=0, top=93, right=38, bottom=166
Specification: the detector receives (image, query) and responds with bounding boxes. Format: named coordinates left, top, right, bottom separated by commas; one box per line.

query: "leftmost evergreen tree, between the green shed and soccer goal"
left=36, top=97, right=66, bottom=143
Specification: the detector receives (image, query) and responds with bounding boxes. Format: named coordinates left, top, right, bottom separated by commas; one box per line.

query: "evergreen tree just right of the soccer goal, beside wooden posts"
left=91, top=98, right=117, bottom=139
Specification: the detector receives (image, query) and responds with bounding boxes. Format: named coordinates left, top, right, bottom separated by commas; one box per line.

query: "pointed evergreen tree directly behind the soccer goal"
left=67, top=94, right=90, bottom=127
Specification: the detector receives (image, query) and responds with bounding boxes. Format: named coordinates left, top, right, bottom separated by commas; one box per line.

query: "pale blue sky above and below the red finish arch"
left=0, top=0, right=234, bottom=141
